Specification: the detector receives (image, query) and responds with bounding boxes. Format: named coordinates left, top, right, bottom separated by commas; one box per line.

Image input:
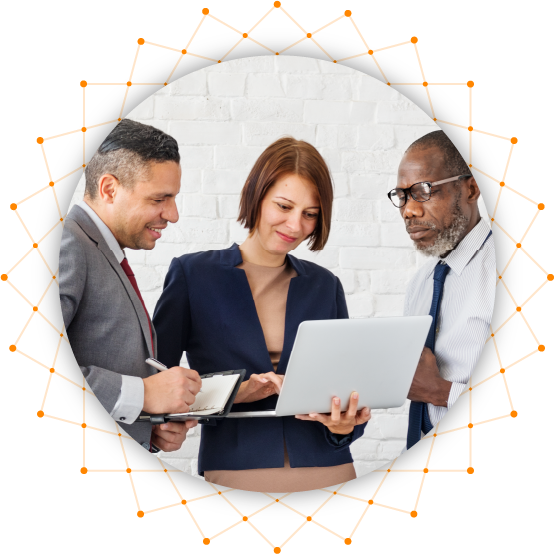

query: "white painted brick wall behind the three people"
left=70, top=56, right=444, bottom=475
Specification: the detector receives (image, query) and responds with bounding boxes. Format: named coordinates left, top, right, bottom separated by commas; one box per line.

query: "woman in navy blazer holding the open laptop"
left=153, top=138, right=370, bottom=492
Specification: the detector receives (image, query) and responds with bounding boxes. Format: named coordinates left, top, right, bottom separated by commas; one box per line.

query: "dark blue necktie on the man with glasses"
left=407, top=260, right=448, bottom=448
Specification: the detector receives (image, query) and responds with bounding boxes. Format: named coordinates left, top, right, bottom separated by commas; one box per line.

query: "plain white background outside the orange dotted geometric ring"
left=0, top=0, right=554, bottom=553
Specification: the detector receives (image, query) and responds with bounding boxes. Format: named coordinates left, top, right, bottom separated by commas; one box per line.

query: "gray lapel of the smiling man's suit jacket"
left=68, top=206, right=156, bottom=357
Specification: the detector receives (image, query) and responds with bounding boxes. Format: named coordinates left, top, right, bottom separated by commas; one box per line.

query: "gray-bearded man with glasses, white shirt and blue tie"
left=388, top=131, right=496, bottom=448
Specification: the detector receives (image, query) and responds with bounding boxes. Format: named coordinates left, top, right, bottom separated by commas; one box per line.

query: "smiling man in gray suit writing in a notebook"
left=59, top=119, right=201, bottom=451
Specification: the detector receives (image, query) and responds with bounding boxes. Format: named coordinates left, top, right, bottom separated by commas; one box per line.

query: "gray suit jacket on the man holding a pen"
left=59, top=206, right=156, bottom=444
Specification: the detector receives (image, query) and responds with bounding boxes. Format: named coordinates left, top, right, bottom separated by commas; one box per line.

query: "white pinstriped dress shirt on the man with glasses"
left=404, top=218, right=496, bottom=426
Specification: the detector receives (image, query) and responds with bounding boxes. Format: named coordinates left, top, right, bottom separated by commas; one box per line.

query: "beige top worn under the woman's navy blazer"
left=204, top=256, right=356, bottom=492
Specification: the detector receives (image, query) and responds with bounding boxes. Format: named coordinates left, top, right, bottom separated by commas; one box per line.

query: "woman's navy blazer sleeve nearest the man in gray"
left=153, top=258, right=191, bottom=367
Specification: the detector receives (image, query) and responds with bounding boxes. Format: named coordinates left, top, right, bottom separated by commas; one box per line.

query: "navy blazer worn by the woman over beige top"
left=153, top=244, right=365, bottom=475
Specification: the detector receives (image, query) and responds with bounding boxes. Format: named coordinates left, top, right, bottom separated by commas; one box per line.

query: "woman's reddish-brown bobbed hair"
left=237, top=137, right=333, bottom=251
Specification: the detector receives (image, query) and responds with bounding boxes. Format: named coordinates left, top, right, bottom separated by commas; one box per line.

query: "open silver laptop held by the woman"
left=227, top=315, right=433, bottom=418
